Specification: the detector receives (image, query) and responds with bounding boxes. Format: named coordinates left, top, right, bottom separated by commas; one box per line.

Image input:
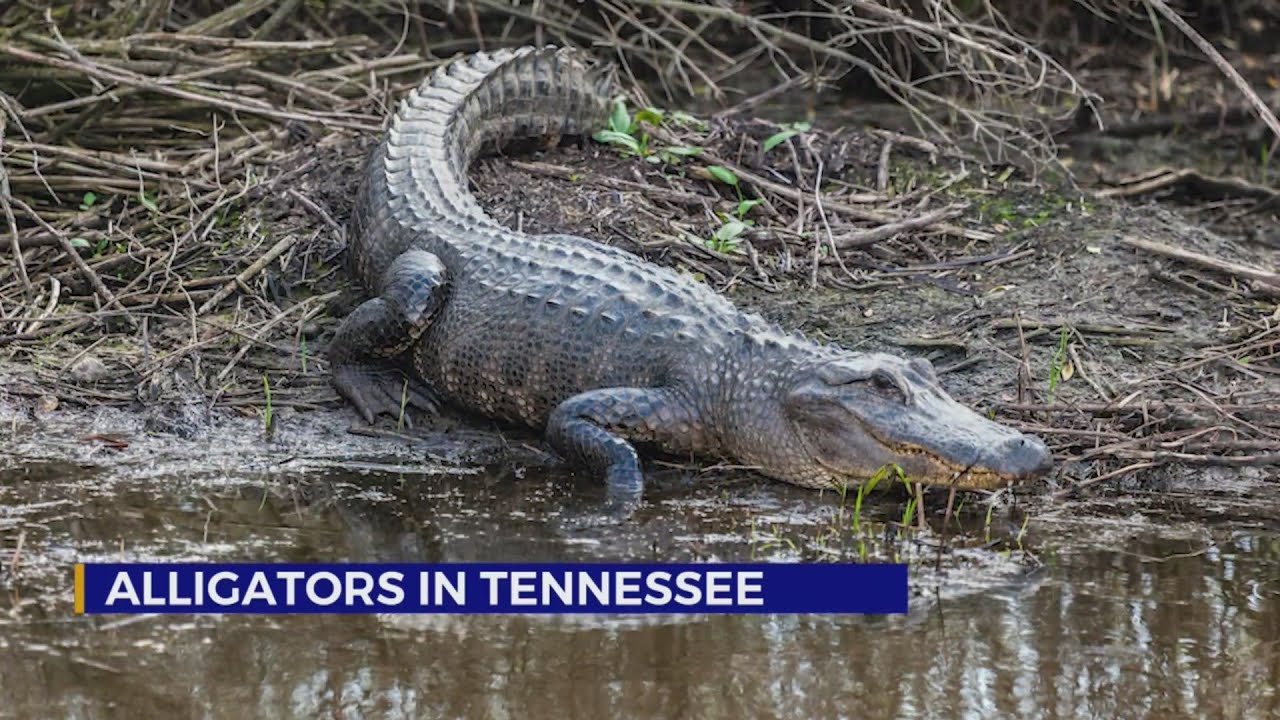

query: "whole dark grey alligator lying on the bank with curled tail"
left=329, top=47, right=1051, bottom=509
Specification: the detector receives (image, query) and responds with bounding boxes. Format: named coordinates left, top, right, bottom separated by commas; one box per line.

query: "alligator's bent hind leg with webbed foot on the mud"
left=329, top=250, right=448, bottom=423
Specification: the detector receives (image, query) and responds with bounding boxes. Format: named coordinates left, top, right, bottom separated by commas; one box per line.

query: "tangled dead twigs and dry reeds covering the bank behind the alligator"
left=0, top=0, right=1280, bottom=504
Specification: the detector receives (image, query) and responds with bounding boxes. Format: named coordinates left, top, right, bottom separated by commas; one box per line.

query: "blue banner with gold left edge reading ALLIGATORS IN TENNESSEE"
left=76, top=562, right=908, bottom=615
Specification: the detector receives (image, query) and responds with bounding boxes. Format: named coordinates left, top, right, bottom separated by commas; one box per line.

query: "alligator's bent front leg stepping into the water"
left=547, top=387, right=701, bottom=512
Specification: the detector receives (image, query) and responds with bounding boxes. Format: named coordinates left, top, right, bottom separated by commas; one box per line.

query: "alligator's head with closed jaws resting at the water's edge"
left=737, top=352, right=1051, bottom=489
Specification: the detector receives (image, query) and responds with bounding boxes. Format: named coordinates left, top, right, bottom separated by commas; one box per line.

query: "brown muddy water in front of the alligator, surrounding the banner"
left=0, top=413, right=1280, bottom=719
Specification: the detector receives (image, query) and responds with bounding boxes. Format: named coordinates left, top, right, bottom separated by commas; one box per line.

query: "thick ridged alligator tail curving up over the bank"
left=351, top=47, right=613, bottom=288
